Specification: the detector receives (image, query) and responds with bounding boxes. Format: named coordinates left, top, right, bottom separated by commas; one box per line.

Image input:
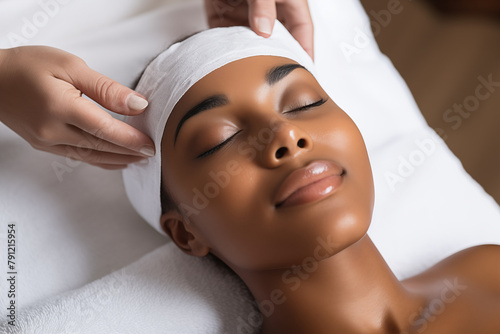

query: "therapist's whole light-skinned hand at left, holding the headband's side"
left=0, top=46, right=154, bottom=169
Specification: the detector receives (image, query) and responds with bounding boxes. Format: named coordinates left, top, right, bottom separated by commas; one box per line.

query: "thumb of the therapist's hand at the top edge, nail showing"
left=248, top=0, right=276, bottom=37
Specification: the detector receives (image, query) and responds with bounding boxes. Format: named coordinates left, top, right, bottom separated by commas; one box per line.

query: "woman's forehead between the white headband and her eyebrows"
left=166, top=56, right=297, bottom=132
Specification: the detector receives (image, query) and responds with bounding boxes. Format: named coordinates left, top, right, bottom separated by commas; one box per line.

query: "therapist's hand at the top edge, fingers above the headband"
left=205, top=0, right=314, bottom=59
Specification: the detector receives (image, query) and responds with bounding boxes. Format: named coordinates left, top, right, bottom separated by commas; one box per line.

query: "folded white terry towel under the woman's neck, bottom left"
left=0, top=243, right=261, bottom=334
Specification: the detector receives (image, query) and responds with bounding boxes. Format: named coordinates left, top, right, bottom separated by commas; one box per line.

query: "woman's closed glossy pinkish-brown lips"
left=274, top=160, right=344, bottom=208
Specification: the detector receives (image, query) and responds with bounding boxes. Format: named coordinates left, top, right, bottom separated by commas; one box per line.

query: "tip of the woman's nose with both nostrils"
left=262, top=122, right=312, bottom=168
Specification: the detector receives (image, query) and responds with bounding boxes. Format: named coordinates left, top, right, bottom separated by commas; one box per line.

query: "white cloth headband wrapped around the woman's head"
left=123, top=21, right=314, bottom=235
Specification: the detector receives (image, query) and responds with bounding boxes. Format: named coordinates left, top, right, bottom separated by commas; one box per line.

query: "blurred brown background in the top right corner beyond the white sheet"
left=361, top=0, right=500, bottom=204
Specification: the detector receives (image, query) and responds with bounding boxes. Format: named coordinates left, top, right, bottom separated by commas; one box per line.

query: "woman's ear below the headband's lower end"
left=160, top=210, right=210, bottom=256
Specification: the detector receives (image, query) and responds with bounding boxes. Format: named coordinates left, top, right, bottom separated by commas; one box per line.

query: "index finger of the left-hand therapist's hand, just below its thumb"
left=68, top=97, right=154, bottom=156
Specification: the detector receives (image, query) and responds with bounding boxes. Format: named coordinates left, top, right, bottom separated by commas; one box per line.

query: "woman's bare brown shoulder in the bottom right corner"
left=402, top=245, right=500, bottom=334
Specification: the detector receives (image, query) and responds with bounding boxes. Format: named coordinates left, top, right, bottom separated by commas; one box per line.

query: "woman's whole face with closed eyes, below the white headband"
left=162, top=56, right=373, bottom=270
